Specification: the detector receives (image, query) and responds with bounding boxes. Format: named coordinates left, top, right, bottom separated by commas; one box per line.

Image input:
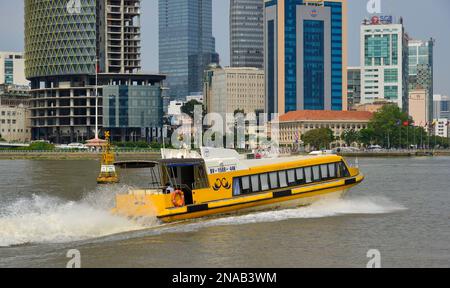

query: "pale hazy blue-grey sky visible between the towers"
left=0, top=0, right=450, bottom=95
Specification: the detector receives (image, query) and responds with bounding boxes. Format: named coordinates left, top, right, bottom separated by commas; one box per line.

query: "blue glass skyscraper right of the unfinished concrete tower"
left=159, top=0, right=219, bottom=100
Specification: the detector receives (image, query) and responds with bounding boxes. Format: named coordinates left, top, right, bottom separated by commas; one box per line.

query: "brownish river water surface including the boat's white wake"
left=0, top=157, right=450, bottom=268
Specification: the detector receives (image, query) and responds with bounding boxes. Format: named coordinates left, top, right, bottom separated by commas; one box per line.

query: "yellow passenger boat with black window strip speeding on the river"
left=113, top=148, right=364, bottom=222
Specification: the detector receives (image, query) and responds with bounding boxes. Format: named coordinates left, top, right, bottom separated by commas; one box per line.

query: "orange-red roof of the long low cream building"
left=280, top=110, right=373, bottom=122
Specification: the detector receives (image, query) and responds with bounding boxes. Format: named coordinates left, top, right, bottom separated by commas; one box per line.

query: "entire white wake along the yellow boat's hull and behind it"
left=0, top=187, right=405, bottom=247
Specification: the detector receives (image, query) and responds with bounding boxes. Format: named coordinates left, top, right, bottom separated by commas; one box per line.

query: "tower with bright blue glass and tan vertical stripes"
left=264, top=0, right=347, bottom=114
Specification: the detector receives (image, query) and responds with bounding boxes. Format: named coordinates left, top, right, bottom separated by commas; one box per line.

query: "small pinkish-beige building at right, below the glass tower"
left=409, top=89, right=433, bottom=127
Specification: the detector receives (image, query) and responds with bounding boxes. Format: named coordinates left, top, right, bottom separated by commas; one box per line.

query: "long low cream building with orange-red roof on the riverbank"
left=279, top=110, right=373, bottom=147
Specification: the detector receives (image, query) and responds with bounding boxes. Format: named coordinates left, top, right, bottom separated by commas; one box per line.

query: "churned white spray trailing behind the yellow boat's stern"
left=0, top=187, right=144, bottom=247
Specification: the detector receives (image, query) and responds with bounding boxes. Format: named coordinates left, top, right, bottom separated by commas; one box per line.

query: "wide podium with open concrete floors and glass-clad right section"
left=30, top=73, right=164, bottom=143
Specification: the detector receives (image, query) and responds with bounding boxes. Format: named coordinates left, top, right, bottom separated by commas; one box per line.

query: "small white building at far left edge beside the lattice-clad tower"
left=0, top=52, right=29, bottom=85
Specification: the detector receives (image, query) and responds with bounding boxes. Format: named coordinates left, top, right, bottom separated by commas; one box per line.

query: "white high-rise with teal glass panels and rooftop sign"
left=361, top=16, right=408, bottom=111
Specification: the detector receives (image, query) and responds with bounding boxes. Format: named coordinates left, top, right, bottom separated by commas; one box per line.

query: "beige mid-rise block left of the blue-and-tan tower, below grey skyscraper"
left=204, top=67, right=265, bottom=119
